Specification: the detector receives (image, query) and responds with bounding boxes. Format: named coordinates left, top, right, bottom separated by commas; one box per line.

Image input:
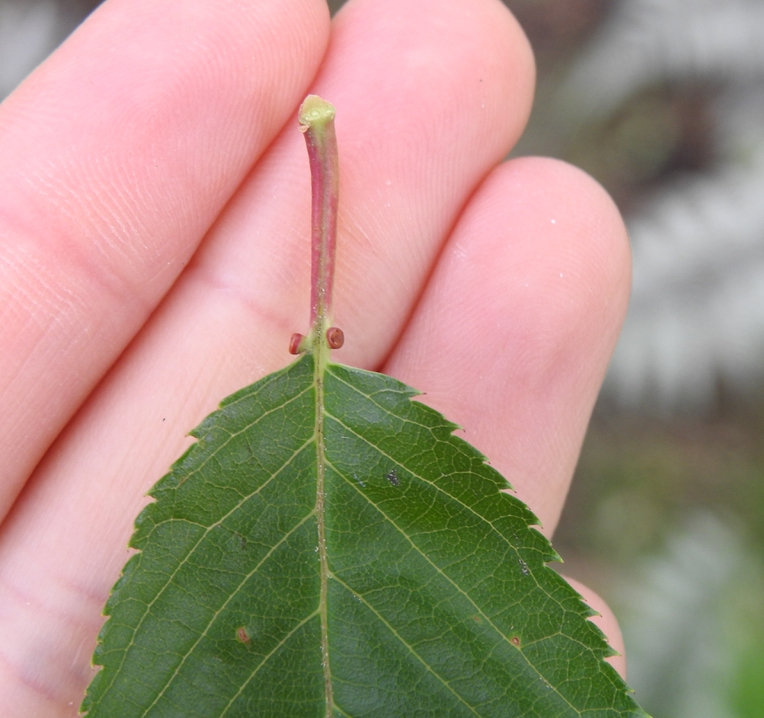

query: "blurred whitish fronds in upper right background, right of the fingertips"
left=558, top=0, right=764, bottom=412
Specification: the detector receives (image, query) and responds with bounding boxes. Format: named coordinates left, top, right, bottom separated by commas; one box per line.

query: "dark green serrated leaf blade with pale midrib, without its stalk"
left=83, top=353, right=645, bottom=718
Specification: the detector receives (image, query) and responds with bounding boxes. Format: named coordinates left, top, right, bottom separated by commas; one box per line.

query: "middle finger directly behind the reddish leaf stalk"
left=0, top=0, right=532, bottom=710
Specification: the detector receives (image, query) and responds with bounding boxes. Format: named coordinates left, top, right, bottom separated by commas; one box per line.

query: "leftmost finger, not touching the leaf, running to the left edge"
left=0, top=0, right=328, bottom=518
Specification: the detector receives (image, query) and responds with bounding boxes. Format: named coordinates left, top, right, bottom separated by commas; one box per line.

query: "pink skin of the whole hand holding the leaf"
left=0, top=0, right=630, bottom=718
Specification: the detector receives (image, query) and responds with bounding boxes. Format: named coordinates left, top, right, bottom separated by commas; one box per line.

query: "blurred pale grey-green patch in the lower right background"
left=622, top=513, right=752, bottom=718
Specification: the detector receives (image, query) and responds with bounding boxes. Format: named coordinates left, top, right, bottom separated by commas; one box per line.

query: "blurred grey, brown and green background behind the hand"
left=0, top=0, right=764, bottom=718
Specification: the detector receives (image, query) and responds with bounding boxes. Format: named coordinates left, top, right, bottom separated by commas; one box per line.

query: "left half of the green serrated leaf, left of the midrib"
left=83, top=362, right=323, bottom=716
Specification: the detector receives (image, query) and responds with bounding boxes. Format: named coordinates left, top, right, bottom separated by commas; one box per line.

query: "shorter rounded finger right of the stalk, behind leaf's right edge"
left=385, top=158, right=631, bottom=536
